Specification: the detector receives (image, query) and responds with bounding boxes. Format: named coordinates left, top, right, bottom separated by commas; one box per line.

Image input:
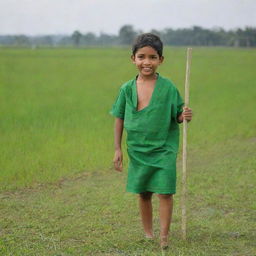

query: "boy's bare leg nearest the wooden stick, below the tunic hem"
left=158, top=194, right=173, bottom=240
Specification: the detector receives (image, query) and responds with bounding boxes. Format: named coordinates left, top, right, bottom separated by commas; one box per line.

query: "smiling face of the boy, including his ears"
left=131, top=46, right=164, bottom=77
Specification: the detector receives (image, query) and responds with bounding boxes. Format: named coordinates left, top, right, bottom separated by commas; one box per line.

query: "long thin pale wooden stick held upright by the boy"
left=181, top=48, right=192, bottom=240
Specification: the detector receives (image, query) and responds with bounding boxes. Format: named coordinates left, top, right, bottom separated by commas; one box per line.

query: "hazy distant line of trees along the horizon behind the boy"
left=0, top=25, right=256, bottom=48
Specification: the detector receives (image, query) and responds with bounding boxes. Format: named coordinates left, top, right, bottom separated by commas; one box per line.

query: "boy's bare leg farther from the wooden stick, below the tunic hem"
left=139, top=192, right=153, bottom=238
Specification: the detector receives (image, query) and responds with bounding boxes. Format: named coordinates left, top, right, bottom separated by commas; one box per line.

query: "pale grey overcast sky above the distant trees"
left=0, top=0, right=256, bottom=35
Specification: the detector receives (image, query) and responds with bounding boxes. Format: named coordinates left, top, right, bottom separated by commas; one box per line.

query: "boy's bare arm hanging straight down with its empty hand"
left=113, top=118, right=124, bottom=172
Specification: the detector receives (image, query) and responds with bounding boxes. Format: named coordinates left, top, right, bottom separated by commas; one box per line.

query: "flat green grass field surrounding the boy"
left=0, top=48, right=256, bottom=256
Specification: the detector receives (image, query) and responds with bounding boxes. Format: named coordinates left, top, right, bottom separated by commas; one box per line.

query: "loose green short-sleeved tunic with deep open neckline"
left=110, top=74, right=184, bottom=194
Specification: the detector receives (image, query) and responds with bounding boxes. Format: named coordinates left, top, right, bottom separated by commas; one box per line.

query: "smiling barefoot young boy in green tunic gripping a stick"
left=111, top=33, right=192, bottom=248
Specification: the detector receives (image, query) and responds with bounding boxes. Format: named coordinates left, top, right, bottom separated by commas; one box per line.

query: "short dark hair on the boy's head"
left=132, top=33, right=163, bottom=57
